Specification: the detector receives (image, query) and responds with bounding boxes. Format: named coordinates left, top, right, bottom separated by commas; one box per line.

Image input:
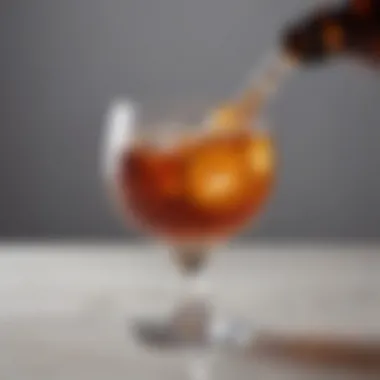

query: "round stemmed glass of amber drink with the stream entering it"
left=98, top=52, right=294, bottom=378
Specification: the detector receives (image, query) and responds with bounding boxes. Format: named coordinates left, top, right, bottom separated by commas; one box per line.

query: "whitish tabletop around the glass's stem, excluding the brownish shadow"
left=0, top=243, right=380, bottom=380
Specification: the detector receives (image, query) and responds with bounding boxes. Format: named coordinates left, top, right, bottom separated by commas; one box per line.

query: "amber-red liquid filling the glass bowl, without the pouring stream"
left=120, top=129, right=275, bottom=240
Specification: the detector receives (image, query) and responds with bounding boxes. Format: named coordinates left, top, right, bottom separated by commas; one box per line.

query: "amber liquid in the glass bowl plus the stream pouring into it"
left=120, top=49, right=293, bottom=242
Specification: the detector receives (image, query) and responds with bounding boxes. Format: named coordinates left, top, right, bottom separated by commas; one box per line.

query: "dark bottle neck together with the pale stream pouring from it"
left=210, top=0, right=380, bottom=130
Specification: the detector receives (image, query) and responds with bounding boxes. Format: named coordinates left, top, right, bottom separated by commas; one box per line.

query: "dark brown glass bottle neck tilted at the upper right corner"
left=282, top=0, right=380, bottom=64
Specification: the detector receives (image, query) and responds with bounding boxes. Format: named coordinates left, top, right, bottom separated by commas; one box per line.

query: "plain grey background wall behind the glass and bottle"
left=0, top=0, right=380, bottom=239
